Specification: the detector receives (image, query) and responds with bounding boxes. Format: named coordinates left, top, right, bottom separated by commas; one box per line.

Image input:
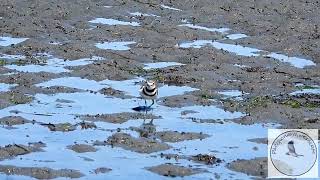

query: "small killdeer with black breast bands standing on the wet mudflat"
left=140, top=80, right=158, bottom=107
